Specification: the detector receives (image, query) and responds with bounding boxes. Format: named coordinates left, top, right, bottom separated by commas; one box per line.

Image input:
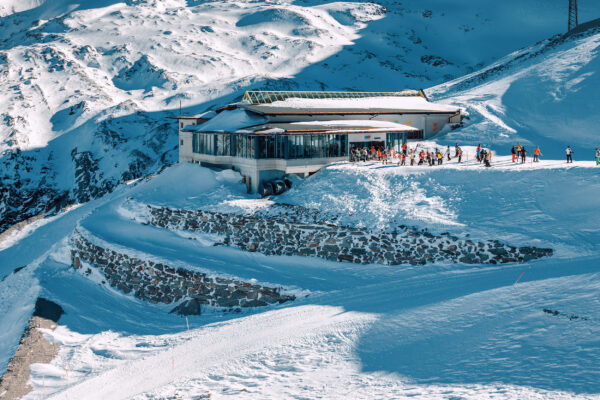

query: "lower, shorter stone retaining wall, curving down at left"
left=71, top=232, right=295, bottom=315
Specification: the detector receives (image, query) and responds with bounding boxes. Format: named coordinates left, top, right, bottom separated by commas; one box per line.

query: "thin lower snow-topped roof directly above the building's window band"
left=185, top=120, right=418, bottom=135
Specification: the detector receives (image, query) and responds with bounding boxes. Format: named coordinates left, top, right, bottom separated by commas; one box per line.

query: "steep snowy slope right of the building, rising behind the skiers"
left=428, top=20, right=600, bottom=159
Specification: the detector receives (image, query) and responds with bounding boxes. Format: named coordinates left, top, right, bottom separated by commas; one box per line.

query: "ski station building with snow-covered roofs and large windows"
left=176, top=90, right=461, bottom=195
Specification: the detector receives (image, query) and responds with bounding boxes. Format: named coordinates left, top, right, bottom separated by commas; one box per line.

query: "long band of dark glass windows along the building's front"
left=192, top=133, right=348, bottom=159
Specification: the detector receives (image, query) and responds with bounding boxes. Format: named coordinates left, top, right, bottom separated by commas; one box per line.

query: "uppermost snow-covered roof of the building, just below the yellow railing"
left=240, top=96, right=460, bottom=115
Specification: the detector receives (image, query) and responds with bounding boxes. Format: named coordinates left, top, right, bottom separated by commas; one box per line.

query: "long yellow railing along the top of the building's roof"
left=242, top=89, right=427, bottom=104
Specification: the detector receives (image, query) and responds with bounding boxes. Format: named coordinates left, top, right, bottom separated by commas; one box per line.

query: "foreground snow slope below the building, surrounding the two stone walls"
left=0, top=150, right=600, bottom=399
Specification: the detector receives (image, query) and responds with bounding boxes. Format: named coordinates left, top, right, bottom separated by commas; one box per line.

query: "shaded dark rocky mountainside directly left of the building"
left=0, top=112, right=177, bottom=233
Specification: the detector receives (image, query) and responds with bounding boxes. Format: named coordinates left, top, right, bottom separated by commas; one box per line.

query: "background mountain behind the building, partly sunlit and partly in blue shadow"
left=0, top=0, right=600, bottom=230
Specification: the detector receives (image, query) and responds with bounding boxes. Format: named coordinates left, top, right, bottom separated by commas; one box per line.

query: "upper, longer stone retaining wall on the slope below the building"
left=145, top=205, right=552, bottom=265
